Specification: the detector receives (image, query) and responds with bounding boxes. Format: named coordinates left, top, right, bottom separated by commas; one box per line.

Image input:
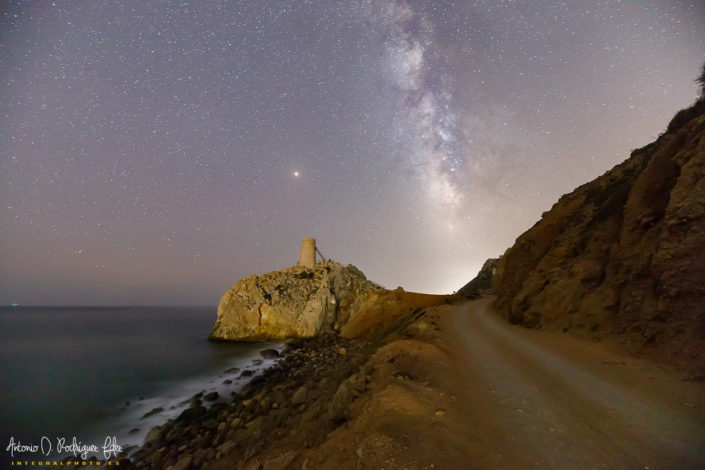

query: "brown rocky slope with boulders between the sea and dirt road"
left=128, top=289, right=456, bottom=470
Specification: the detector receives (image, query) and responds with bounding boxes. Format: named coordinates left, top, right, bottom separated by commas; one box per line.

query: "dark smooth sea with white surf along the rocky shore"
left=0, top=307, right=284, bottom=468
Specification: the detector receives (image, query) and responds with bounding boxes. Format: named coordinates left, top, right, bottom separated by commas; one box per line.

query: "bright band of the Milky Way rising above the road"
left=371, top=3, right=463, bottom=220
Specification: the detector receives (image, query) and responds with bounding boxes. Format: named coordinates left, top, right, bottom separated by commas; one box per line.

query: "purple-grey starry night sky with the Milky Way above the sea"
left=0, top=0, right=705, bottom=305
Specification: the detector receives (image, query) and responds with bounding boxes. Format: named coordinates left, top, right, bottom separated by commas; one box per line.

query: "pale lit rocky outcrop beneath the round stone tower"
left=210, top=262, right=382, bottom=341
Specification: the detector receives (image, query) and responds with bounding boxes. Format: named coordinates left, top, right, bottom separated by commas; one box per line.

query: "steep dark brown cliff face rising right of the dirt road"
left=493, top=102, right=705, bottom=366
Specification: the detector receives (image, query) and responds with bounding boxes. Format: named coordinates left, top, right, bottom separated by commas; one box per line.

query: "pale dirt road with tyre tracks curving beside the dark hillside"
left=443, top=298, right=705, bottom=470
